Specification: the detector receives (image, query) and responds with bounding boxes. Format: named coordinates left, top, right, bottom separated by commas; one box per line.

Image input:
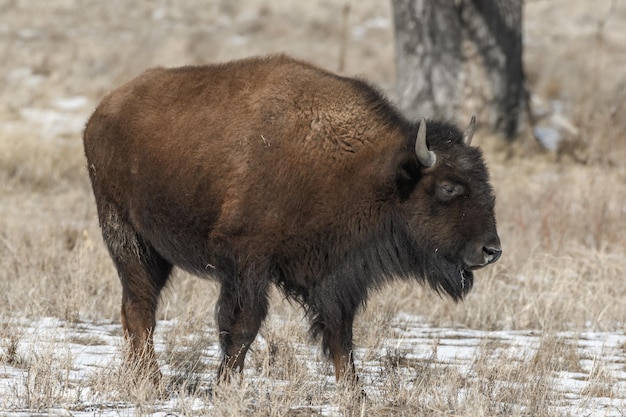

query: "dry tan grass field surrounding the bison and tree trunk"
left=0, top=0, right=626, bottom=417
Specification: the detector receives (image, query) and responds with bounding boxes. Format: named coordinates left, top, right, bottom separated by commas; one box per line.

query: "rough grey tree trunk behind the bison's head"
left=392, top=0, right=526, bottom=139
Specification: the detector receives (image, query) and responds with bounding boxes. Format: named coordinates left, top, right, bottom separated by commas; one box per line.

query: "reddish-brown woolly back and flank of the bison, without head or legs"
left=84, top=56, right=402, bottom=273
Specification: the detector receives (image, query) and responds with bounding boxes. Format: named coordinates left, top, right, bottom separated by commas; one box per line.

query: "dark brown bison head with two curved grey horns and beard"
left=396, top=117, right=502, bottom=300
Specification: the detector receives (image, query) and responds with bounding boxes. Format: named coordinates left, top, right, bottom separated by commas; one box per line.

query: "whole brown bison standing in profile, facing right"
left=84, top=55, right=501, bottom=380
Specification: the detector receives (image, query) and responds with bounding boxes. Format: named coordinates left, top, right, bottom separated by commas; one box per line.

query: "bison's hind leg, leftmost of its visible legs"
left=98, top=202, right=172, bottom=386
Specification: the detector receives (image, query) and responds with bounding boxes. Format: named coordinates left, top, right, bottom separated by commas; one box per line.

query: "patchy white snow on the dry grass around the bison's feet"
left=0, top=315, right=626, bottom=417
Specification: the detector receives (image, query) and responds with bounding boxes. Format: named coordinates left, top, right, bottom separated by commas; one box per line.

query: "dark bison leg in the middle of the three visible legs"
left=216, top=282, right=268, bottom=381
